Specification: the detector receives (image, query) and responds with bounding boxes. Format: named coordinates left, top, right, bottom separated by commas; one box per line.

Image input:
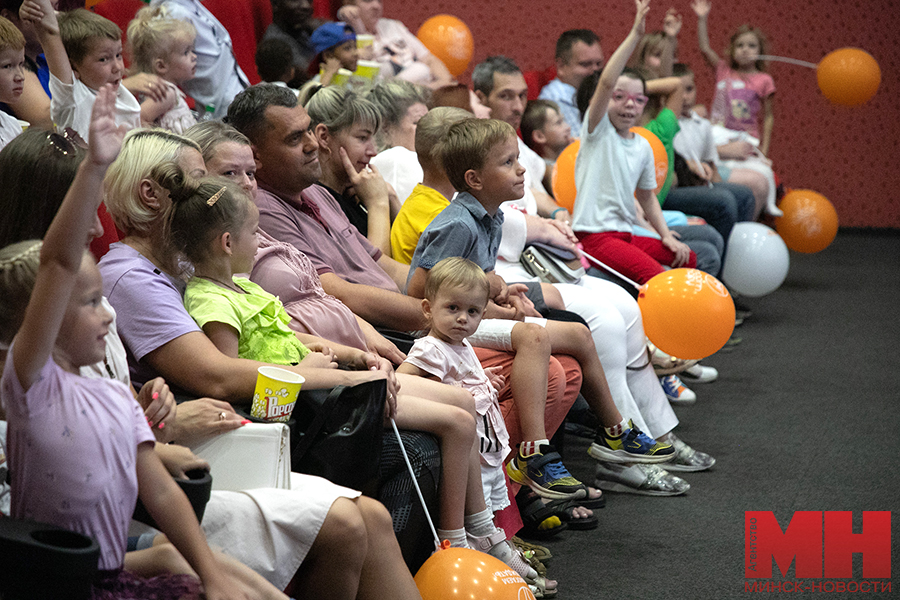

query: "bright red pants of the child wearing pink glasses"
left=575, top=231, right=697, bottom=283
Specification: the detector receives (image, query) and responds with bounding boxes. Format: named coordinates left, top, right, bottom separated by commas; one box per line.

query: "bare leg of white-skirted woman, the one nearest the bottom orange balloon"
left=356, top=496, right=421, bottom=600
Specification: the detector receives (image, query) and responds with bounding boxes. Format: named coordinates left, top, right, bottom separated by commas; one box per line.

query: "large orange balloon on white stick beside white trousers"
left=638, top=269, right=734, bottom=360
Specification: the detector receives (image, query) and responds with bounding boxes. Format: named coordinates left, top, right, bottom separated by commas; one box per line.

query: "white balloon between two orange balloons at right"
left=722, top=221, right=790, bottom=298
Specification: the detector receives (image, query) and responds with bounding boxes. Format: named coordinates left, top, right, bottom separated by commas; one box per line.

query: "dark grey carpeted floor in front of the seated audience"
left=546, top=232, right=900, bottom=600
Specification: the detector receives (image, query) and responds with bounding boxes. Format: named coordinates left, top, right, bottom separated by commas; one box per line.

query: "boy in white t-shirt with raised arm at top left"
left=19, top=0, right=141, bottom=141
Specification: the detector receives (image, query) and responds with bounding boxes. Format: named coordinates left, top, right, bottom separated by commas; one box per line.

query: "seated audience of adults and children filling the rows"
left=0, top=0, right=792, bottom=599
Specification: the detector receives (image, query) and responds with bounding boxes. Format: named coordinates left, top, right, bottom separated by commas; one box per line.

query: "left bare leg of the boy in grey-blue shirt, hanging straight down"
left=509, top=323, right=550, bottom=441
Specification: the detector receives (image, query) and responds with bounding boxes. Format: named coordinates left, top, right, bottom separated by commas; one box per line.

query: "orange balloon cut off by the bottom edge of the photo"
left=415, top=548, right=535, bottom=600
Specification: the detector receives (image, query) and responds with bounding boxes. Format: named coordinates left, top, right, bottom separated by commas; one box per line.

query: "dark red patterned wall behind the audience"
left=385, top=0, right=900, bottom=228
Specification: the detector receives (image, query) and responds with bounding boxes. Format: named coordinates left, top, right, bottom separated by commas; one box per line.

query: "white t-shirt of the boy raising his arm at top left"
left=50, top=73, right=141, bottom=142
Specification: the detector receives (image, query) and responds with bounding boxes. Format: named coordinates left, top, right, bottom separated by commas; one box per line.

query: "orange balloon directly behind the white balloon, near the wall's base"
left=775, top=190, right=838, bottom=254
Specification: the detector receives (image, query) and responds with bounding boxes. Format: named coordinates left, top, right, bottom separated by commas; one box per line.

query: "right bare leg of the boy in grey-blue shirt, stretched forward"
left=545, top=321, right=622, bottom=427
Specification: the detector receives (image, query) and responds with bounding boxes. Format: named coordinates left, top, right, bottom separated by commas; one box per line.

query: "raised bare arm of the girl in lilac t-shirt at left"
left=13, top=85, right=125, bottom=390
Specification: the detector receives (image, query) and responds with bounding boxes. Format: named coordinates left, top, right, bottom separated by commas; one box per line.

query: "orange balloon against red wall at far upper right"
left=816, top=48, right=881, bottom=106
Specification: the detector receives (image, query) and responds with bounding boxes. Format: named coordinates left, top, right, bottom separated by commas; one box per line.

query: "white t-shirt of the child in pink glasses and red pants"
left=572, top=114, right=656, bottom=233
